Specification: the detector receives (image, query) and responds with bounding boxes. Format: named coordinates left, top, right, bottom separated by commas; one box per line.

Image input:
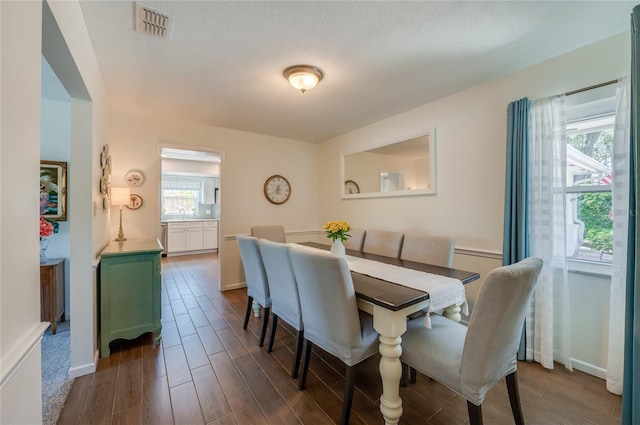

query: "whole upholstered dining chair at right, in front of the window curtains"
left=400, top=257, right=542, bottom=425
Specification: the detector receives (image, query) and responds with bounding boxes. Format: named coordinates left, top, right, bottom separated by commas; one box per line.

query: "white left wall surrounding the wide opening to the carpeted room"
left=0, top=1, right=107, bottom=424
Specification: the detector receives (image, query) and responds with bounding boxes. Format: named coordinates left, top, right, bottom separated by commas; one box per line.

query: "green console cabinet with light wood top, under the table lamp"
left=98, top=239, right=162, bottom=357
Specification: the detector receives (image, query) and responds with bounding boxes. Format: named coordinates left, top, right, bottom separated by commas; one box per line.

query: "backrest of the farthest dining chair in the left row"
left=236, top=235, right=271, bottom=307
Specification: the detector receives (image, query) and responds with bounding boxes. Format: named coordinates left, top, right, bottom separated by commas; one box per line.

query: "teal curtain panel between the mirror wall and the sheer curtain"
left=502, top=97, right=531, bottom=360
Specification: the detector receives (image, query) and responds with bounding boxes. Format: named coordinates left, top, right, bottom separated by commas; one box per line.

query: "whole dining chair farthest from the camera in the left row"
left=236, top=235, right=271, bottom=347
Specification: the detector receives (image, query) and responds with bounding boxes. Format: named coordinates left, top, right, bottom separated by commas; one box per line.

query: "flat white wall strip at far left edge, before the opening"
left=0, top=2, right=46, bottom=424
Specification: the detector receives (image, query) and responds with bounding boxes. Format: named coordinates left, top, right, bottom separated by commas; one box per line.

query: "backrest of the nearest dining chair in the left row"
left=290, top=247, right=364, bottom=366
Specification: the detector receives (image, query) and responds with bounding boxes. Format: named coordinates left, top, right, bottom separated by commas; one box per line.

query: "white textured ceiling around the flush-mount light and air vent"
left=80, top=0, right=637, bottom=142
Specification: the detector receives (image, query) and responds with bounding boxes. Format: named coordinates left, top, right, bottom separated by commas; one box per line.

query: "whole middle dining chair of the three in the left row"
left=258, top=239, right=304, bottom=378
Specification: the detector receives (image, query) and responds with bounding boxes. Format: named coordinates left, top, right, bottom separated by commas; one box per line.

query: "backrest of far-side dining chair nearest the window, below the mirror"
left=400, top=235, right=456, bottom=268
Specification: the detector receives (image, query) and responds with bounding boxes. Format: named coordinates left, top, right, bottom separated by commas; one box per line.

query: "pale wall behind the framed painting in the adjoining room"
left=40, top=98, right=71, bottom=314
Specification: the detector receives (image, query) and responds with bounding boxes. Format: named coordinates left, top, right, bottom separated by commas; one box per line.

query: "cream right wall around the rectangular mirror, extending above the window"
left=318, top=33, right=630, bottom=374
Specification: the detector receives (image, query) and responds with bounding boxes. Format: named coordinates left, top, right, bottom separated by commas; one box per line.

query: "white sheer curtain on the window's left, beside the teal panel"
left=526, top=95, right=572, bottom=370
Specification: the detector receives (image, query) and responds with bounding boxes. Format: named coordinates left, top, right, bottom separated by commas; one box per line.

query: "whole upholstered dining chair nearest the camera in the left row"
left=290, top=247, right=379, bottom=425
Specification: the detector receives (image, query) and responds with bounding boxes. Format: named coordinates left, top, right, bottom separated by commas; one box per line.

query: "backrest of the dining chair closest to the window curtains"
left=460, top=257, right=542, bottom=404
